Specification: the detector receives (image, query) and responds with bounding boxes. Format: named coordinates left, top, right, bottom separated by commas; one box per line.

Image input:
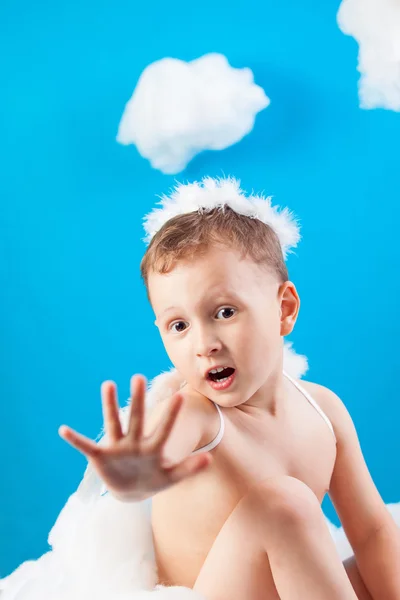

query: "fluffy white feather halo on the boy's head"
left=143, top=177, right=301, bottom=260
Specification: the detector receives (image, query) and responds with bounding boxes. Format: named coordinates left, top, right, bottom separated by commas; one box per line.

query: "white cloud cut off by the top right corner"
left=338, top=0, right=400, bottom=111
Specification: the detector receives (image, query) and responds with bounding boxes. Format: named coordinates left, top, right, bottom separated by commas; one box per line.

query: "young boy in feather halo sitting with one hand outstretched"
left=60, top=179, right=400, bottom=600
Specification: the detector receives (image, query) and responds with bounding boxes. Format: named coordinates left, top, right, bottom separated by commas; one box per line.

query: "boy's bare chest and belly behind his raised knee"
left=152, top=396, right=336, bottom=587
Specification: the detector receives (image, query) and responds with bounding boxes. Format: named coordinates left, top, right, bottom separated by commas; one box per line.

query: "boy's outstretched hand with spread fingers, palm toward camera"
left=59, top=375, right=212, bottom=502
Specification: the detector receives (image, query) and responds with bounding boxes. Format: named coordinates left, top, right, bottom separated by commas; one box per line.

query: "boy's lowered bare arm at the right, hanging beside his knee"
left=322, top=388, right=400, bottom=600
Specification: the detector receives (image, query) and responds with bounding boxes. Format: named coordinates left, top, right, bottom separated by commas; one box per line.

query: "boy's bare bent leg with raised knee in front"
left=193, top=476, right=357, bottom=600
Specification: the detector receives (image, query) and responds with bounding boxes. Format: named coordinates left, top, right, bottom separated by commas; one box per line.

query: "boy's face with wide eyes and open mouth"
left=148, top=248, right=297, bottom=406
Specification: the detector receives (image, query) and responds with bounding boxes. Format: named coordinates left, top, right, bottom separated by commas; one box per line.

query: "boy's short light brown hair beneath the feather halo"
left=140, top=205, right=289, bottom=294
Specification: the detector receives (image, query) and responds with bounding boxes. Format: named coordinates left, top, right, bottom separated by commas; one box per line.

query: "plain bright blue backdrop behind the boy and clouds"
left=0, top=0, right=400, bottom=576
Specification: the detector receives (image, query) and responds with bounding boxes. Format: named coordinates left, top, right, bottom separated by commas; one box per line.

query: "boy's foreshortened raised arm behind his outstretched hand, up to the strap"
left=143, top=386, right=218, bottom=465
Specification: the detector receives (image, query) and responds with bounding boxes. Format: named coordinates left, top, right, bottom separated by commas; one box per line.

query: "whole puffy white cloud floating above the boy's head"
left=117, top=53, right=270, bottom=173
